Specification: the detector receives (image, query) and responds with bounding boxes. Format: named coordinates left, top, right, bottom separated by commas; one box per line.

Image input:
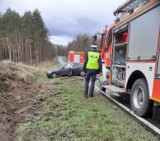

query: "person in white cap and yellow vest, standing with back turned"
left=83, top=45, right=102, bottom=98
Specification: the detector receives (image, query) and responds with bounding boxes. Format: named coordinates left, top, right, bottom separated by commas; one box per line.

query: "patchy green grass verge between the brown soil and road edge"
left=17, top=77, right=157, bottom=141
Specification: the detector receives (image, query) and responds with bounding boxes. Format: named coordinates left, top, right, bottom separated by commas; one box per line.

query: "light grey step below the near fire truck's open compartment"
left=102, top=85, right=126, bottom=93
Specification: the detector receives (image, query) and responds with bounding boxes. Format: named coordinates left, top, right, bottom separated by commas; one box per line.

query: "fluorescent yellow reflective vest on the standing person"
left=86, top=51, right=99, bottom=69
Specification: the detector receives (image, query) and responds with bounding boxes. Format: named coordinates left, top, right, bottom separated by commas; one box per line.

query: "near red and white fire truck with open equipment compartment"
left=97, top=0, right=160, bottom=117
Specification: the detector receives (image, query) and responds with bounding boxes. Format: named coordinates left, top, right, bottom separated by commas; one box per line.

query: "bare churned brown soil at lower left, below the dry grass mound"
left=0, top=81, right=42, bottom=141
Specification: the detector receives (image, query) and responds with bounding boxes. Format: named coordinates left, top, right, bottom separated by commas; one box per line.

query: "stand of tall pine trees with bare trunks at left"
left=0, top=8, right=61, bottom=65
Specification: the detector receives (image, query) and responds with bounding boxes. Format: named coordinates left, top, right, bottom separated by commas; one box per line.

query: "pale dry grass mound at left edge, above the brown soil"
left=0, top=61, right=35, bottom=92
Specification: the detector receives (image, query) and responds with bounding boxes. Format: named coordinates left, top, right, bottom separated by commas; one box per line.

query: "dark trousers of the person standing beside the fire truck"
left=84, top=71, right=97, bottom=96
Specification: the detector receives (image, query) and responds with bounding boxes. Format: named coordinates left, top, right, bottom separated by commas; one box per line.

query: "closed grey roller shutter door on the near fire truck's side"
left=128, top=6, right=160, bottom=60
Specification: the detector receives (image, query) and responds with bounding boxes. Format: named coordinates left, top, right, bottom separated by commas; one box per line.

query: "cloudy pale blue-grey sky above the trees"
left=0, top=0, right=126, bottom=45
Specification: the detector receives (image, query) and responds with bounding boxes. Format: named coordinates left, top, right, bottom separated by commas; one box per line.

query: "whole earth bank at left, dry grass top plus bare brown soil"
left=0, top=61, right=45, bottom=141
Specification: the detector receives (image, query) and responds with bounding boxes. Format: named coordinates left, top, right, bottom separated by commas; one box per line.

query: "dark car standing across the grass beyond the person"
left=46, top=63, right=83, bottom=78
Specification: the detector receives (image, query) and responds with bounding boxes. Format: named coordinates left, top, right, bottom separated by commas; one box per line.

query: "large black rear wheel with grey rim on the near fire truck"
left=130, top=78, right=153, bottom=117
